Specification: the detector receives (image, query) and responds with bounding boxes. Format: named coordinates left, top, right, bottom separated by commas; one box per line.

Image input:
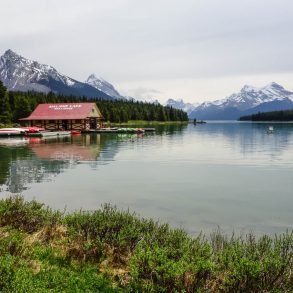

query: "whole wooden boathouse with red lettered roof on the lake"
left=19, top=103, right=104, bottom=131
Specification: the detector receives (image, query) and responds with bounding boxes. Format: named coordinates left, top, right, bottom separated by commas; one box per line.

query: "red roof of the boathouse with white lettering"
left=20, top=103, right=102, bottom=120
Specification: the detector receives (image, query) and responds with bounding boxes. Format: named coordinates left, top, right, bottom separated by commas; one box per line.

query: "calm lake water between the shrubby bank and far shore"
left=0, top=122, right=293, bottom=234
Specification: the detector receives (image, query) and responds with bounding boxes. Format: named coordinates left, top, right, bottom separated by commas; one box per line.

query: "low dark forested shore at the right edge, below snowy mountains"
left=239, top=109, right=293, bottom=121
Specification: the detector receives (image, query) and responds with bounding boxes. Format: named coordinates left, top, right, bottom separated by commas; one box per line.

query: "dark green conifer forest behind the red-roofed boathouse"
left=0, top=81, right=188, bottom=124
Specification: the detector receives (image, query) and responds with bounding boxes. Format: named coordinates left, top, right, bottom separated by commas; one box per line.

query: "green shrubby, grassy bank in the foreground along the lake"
left=0, top=197, right=293, bottom=292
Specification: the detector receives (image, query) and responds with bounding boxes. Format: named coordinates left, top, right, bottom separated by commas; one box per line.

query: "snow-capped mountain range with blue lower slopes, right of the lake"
left=168, top=82, right=293, bottom=120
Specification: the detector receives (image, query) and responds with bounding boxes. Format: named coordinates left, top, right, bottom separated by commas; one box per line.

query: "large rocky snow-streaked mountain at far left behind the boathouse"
left=0, top=50, right=113, bottom=99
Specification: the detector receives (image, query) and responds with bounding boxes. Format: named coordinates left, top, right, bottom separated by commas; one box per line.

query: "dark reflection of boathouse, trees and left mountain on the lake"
left=0, top=125, right=186, bottom=193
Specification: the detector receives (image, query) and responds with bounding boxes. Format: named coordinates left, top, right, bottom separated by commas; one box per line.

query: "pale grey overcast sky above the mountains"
left=0, top=0, right=293, bottom=102
